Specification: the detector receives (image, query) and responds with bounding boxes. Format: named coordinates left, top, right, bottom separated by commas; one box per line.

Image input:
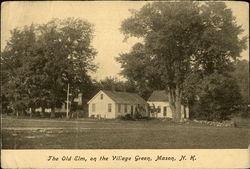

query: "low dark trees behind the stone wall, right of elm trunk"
left=188, top=60, right=249, bottom=120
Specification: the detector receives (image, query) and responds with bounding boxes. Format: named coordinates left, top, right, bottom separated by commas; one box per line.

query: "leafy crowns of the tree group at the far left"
left=1, top=18, right=96, bottom=115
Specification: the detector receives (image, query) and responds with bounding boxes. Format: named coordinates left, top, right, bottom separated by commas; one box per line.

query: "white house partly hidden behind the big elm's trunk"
left=148, top=90, right=189, bottom=118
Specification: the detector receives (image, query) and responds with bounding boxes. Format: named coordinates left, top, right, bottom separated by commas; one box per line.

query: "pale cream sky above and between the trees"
left=1, top=1, right=249, bottom=80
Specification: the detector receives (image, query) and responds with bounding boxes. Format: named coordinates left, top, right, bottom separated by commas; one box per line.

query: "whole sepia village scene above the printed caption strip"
left=0, top=1, right=250, bottom=153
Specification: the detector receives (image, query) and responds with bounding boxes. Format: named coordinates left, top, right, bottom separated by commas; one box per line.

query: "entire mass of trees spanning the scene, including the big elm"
left=1, top=2, right=249, bottom=121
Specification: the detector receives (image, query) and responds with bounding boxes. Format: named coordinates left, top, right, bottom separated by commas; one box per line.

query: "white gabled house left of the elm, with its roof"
left=88, top=90, right=147, bottom=119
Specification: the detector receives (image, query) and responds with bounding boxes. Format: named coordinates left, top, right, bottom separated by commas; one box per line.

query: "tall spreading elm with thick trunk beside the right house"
left=117, top=2, right=247, bottom=120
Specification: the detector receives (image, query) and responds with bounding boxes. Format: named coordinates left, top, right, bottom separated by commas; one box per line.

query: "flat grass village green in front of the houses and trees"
left=2, top=118, right=250, bottom=149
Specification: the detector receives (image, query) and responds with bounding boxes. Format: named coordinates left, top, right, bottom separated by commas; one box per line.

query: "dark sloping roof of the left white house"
left=102, top=90, right=147, bottom=104
